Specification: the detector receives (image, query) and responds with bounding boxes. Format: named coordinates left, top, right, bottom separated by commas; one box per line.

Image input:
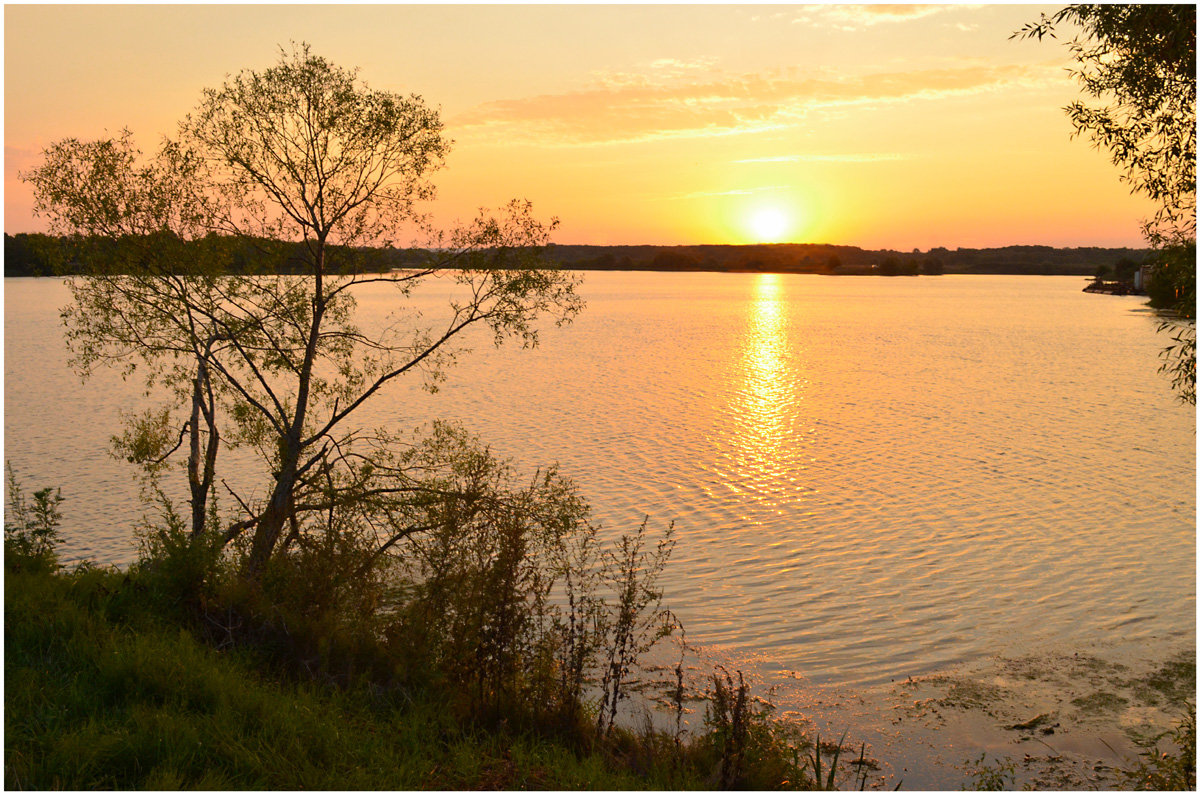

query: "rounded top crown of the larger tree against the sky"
left=181, top=43, right=449, bottom=245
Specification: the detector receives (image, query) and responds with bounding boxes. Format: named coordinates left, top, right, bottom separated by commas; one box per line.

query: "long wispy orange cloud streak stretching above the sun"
left=449, top=64, right=1061, bottom=147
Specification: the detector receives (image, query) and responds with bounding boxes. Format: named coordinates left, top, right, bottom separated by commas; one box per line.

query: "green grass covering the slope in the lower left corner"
left=5, top=570, right=704, bottom=790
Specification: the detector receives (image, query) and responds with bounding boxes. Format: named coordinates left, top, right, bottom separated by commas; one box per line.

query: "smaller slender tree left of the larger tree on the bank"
left=24, top=131, right=228, bottom=534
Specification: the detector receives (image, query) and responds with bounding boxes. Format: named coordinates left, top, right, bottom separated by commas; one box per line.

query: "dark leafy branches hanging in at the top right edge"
left=1013, top=4, right=1196, bottom=405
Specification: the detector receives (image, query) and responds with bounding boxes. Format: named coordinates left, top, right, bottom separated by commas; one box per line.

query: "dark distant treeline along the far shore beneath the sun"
left=4, top=234, right=1150, bottom=276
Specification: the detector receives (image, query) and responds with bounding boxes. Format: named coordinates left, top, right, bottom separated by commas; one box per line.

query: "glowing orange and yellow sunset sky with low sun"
left=4, top=5, right=1153, bottom=251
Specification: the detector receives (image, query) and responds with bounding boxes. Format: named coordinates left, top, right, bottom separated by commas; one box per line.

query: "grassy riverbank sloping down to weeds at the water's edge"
left=5, top=557, right=883, bottom=790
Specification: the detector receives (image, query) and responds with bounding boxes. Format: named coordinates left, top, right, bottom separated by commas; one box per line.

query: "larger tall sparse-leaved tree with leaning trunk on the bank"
left=21, top=44, right=581, bottom=576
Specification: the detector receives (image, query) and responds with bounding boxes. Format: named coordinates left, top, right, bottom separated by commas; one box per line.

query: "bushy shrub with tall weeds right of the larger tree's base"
left=386, top=425, right=673, bottom=730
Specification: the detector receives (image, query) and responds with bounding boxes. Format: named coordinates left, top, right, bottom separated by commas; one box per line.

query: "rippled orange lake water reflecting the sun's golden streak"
left=5, top=273, right=1195, bottom=686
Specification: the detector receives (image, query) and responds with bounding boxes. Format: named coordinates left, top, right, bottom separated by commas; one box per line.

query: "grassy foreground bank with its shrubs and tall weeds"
left=5, top=468, right=873, bottom=789
